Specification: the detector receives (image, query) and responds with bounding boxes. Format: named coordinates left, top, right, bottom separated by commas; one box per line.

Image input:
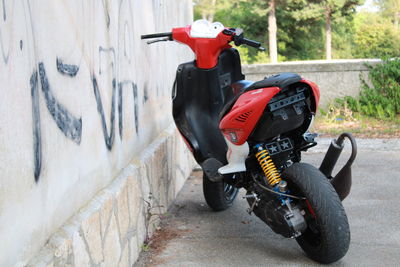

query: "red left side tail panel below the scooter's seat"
left=219, top=87, right=281, bottom=145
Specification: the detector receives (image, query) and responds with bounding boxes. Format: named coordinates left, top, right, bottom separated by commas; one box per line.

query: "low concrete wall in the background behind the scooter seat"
left=243, top=59, right=380, bottom=107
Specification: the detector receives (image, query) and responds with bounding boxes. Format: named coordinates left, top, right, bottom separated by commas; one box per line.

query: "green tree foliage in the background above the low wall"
left=195, top=0, right=400, bottom=63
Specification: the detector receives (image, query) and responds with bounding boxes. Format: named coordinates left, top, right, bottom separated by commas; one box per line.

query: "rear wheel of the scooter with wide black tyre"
left=282, top=163, right=350, bottom=263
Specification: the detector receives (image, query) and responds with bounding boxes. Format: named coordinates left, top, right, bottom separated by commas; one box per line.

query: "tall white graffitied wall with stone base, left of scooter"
left=0, top=0, right=193, bottom=266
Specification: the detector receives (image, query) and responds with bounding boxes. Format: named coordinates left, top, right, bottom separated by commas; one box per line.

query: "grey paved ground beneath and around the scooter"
left=135, top=140, right=400, bottom=266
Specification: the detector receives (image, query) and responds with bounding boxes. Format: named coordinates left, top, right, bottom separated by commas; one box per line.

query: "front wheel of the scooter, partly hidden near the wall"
left=203, top=174, right=239, bottom=211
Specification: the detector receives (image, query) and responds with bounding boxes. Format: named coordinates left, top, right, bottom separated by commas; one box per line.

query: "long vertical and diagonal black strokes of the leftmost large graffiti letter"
left=30, top=62, right=82, bottom=182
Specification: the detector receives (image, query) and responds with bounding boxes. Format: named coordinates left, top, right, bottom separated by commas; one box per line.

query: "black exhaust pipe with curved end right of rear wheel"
left=319, top=133, right=357, bottom=201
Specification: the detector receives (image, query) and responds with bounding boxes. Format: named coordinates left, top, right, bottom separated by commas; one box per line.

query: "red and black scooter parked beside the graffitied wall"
left=142, top=20, right=356, bottom=263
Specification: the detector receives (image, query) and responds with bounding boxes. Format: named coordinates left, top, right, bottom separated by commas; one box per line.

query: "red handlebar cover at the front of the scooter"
left=172, top=26, right=232, bottom=69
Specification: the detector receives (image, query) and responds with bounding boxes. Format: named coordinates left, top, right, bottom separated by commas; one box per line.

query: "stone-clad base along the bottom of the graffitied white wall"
left=28, top=126, right=193, bottom=266
